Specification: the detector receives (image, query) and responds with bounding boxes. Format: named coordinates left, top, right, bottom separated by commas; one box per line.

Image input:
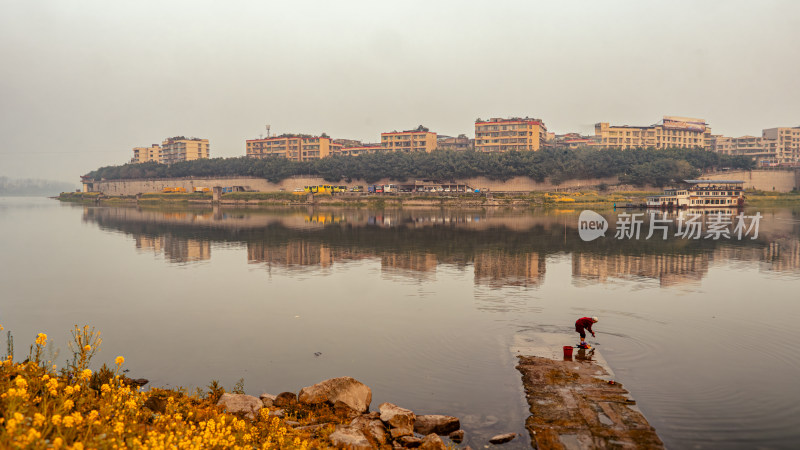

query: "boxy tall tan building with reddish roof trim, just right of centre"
left=475, top=117, right=547, bottom=152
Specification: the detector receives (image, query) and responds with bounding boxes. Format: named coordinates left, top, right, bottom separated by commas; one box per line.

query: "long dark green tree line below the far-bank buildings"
left=87, top=148, right=753, bottom=186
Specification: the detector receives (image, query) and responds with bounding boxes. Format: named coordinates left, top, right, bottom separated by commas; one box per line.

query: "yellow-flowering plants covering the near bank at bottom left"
left=0, top=326, right=354, bottom=450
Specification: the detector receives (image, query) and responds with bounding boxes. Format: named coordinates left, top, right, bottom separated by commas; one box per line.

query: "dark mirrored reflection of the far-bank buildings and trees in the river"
left=83, top=203, right=800, bottom=287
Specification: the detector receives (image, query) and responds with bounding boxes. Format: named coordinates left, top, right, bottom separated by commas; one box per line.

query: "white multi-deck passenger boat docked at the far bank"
left=647, top=180, right=745, bottom=209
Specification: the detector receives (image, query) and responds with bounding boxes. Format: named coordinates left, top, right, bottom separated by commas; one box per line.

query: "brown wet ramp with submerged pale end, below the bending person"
left=511, top=333, right=664, bottom=449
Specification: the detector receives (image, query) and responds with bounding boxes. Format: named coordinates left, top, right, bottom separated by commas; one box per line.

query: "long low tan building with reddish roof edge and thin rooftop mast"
left=246, top=134, right=342, bottom=161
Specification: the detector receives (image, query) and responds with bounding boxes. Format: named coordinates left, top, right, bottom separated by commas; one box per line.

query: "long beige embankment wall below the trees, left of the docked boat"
left=90, top=177, right=619, bottom=195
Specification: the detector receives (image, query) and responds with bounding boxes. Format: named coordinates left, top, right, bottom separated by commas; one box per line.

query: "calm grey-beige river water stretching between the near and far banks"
left=0, top=198, right=800, bottom=448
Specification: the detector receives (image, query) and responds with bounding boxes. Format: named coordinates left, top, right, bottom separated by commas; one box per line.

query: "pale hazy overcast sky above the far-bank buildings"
left=0, top=0, right=800, bottom=182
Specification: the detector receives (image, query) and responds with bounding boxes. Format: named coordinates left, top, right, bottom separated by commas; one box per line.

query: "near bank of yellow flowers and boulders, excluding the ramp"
left=0, top=326, right=515, bottom=450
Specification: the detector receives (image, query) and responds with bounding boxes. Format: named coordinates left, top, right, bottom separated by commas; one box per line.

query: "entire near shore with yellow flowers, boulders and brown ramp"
left=0, top=326, right=663, bottom=450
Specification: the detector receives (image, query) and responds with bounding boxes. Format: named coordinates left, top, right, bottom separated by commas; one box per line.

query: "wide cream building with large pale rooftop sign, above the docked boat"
left=594, top=116, right=711, bottom=150
